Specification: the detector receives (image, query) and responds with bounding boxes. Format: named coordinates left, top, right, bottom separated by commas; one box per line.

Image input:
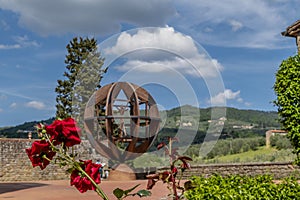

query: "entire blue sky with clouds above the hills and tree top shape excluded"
left=0, top=0, right=300, bottom=127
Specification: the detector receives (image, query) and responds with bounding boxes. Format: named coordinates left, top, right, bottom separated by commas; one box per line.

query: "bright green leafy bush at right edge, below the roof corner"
left=274, top=55, right=300, bottom=165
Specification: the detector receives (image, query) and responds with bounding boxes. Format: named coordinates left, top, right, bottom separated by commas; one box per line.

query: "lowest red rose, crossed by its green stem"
left=71, top=160, right=101, bottom=193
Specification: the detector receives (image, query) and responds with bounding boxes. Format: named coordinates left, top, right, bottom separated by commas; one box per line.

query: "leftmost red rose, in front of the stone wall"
left=26, top=140, right=55, bottom=170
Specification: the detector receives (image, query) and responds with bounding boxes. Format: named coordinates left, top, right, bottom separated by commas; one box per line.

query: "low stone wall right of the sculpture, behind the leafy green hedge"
left=158, top=162, right=300, bottom=179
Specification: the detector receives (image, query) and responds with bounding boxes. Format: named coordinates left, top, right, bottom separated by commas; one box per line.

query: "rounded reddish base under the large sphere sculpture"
left=107, top=164, right=136, bottom=181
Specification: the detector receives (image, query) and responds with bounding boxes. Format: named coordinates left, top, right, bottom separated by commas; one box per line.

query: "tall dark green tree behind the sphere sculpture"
left=55, top=37, right=106, bottom=121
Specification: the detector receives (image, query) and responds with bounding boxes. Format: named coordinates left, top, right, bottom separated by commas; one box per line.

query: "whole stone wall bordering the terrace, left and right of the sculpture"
left=0, top=138, right=300, bottom=182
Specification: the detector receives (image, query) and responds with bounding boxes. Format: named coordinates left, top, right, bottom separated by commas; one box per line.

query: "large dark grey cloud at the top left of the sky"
left=0, top=0, right=175, bottom=35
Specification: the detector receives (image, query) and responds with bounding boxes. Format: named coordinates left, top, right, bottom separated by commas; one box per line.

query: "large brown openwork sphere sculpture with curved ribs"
left=84, top=82, right=160, bottom=162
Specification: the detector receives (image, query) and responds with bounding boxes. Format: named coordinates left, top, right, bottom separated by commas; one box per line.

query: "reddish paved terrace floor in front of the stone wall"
left=0, top=180, right=169, bottom=200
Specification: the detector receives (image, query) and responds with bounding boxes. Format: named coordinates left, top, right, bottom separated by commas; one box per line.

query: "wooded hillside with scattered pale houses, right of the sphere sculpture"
left=165, top=105, right=280, bottom=130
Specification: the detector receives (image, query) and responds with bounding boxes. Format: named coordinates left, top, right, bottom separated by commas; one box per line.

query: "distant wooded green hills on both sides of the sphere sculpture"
left=0, top=105, right=280, bottom=139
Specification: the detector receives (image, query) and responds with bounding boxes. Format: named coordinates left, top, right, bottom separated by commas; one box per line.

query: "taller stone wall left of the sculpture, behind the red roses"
left=0, top=138, right=101, bottom=182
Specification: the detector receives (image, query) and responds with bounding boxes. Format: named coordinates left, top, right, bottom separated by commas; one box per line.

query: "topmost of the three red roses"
left=45, top=118, right=81, bottom=147
